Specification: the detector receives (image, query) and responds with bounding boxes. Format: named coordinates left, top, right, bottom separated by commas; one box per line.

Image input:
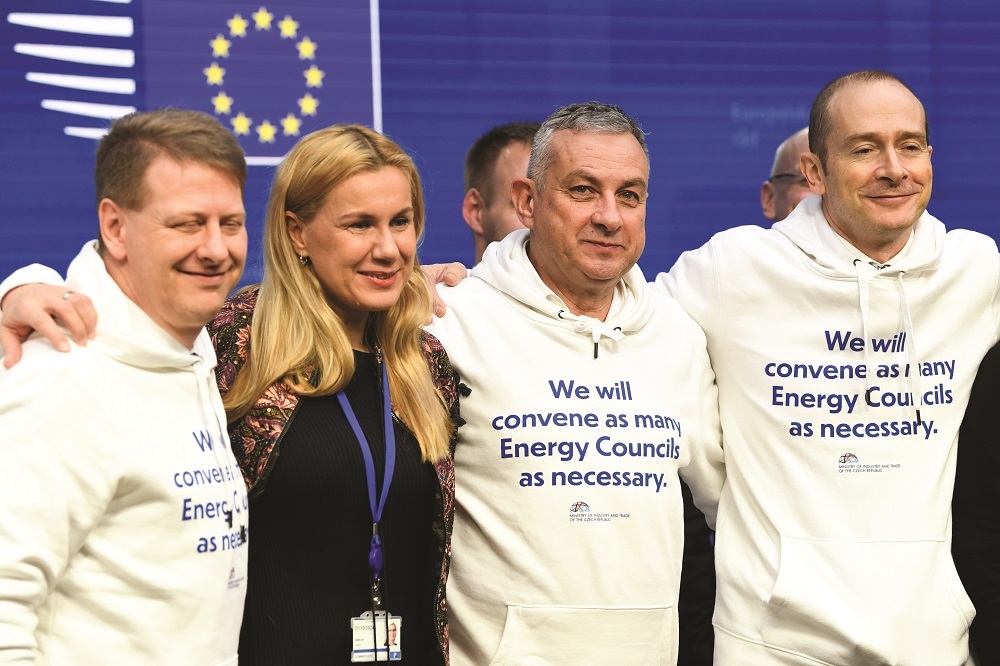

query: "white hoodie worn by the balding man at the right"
left=657, top=196, right=1000, bottom=666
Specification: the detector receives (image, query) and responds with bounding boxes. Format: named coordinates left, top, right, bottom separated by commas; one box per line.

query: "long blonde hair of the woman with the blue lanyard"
left=223, top=125, right=454, bottom=461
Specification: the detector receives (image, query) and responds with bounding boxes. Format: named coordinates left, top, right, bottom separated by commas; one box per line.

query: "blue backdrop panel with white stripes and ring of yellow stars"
left=0, top=0, right=381, bottom=282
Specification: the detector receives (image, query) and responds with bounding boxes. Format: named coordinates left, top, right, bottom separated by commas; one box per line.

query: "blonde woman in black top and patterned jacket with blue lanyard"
left=209, top=125, right=458, bottom=666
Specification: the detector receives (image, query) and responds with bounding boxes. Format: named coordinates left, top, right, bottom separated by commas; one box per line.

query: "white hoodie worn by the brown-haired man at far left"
left=0, top=245, right=247, bottom=666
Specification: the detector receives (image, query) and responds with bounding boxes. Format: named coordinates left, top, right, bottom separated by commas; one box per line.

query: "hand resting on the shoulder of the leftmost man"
left=0, top=284, right=97, bottom=368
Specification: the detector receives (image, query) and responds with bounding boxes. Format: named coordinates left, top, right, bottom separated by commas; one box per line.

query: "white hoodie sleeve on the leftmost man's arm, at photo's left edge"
left=0, top=356, right=115, bottom=664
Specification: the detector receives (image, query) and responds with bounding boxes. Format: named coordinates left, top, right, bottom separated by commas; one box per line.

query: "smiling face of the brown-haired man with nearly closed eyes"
left=98, top=156, right=247, bottom=347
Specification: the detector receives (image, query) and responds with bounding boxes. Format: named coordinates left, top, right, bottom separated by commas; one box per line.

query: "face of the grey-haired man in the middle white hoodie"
left=514, top=130, right=649, bottom=319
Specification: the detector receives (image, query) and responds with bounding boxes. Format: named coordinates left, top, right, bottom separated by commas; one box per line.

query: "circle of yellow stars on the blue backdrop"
left=202, top=6, right=326, bottom=143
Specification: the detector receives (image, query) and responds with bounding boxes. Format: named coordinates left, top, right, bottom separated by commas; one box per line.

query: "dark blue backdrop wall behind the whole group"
left=0, top=0, right=1000, bottom=281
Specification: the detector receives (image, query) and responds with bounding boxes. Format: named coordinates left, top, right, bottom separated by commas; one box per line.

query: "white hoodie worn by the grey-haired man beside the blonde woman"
left=431, top=230, right=723, bottom=666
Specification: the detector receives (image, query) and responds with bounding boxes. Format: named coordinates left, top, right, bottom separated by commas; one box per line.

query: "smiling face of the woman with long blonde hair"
left=286, top=166, right=417, bottom=345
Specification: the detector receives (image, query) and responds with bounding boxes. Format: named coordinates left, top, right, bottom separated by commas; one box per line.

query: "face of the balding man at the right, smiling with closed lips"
left=802, top=81, right=933, bottom=262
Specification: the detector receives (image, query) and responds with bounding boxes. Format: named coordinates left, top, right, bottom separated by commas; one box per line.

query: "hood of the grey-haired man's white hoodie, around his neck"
left=471, top=229, right=653, bottom=357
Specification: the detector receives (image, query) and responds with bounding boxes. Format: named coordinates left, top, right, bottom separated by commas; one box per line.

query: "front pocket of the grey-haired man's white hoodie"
left=490, top=606, right=677, bottom=666
